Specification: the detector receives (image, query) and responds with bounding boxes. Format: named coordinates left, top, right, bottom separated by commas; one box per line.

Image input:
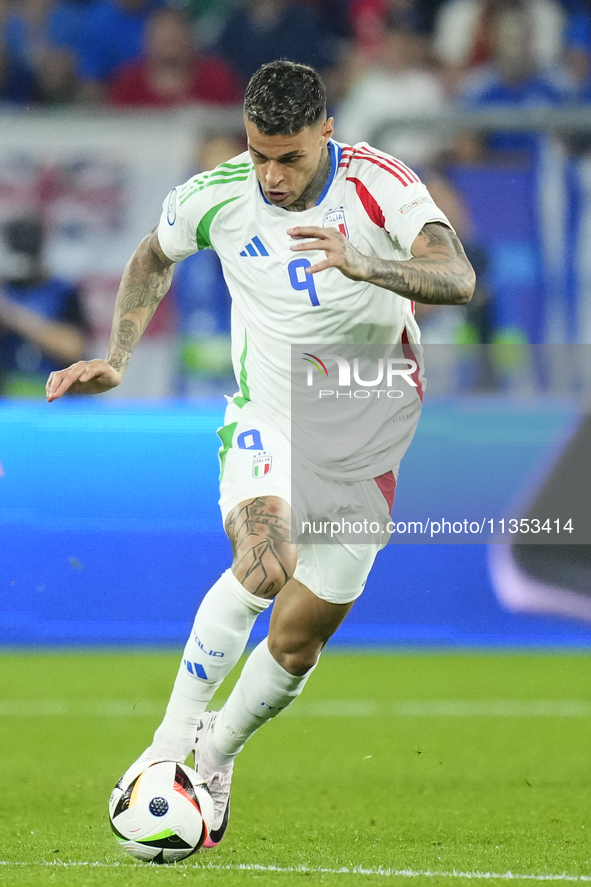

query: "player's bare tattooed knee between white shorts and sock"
left=226, top=496, right=291, bottom=598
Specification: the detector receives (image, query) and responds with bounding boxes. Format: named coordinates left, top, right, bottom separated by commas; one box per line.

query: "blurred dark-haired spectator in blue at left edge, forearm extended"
left=0, top=218, right=87, bottom=396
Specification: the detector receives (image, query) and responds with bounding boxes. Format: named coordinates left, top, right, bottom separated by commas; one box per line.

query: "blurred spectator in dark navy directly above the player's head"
left=217, top=0, right=336, bottom=84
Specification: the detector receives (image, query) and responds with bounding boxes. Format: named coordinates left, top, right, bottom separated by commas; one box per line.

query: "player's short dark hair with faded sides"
left=244, top=59, right=326, bottom=136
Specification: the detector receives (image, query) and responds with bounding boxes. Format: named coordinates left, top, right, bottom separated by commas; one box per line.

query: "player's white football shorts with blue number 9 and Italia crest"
left=218, top=402, right=397, bottom=604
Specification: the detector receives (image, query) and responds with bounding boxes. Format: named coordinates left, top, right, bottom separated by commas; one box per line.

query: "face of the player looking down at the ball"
left=245, top=117, right=334, bottom=206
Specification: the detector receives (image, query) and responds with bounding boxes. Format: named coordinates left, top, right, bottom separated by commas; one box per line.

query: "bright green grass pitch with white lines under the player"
left=0, top=652, right=591, bottom=887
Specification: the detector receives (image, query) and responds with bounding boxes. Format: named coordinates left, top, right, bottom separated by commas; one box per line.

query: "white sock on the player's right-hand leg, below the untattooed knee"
left=207, top=638, right=316, bottom=767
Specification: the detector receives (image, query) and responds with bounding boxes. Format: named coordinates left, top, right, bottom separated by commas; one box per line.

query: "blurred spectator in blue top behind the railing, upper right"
left=461, top=0, right=572, bottom=158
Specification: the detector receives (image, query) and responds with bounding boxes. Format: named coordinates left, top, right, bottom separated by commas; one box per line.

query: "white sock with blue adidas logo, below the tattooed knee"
left=147, top=570, right=273, bottom=762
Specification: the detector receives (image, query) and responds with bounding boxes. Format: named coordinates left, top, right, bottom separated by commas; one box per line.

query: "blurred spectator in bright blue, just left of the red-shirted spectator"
left=79, top=0, right=165, bottom=102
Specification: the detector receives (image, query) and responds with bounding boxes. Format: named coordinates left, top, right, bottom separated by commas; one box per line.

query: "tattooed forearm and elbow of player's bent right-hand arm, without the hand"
left=368, top=222, right=475, bottom=305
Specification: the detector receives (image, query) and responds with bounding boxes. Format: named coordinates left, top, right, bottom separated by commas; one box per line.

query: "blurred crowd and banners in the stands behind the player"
left=0, top=0, right=591, bottom=397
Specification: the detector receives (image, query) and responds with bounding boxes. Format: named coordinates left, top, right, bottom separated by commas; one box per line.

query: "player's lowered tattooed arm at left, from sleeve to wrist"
left=106, top=231, right=173, bottom=375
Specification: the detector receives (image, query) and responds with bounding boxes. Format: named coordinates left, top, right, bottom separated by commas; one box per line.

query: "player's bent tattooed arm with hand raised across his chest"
left=288, top=222, right=476, bottom=305
